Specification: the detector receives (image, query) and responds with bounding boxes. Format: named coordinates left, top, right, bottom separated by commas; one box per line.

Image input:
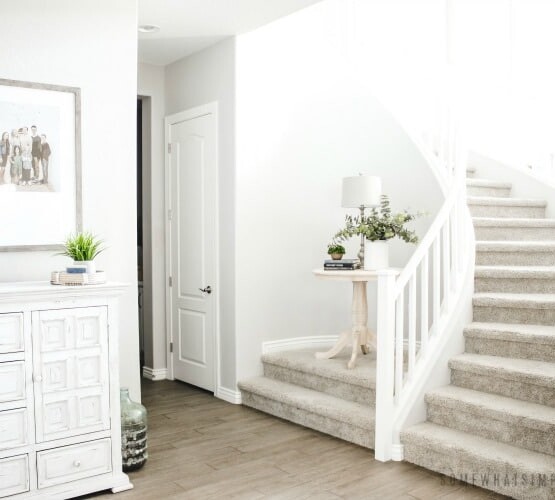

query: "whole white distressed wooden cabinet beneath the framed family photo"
left=0, top=282, right=132, bottom=500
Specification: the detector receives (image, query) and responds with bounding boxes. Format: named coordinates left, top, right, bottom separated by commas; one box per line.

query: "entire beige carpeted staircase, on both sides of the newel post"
left=239, top=169, right=555, bottom=500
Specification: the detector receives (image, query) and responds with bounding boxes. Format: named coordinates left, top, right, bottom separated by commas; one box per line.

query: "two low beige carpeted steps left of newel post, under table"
left=239, top=349, right=376, bottom=448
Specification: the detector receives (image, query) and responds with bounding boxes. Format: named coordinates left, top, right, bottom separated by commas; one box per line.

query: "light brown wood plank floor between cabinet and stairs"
left=82, top=380, right=505, bottom=500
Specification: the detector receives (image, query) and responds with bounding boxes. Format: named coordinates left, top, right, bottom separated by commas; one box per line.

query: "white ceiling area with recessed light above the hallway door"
left=139, top=0, right=320, bottom=66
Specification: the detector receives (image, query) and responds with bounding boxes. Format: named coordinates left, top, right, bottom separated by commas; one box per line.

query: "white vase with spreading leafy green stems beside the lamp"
left=333, top=195, right=422, bottom=271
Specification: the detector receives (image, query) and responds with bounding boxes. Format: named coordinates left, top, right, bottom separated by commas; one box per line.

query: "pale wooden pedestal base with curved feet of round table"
left=315, top=281, right=376, bottom=369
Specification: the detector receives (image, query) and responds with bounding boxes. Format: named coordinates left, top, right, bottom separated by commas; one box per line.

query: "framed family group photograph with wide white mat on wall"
left=0, top=79, right=82, bottom=252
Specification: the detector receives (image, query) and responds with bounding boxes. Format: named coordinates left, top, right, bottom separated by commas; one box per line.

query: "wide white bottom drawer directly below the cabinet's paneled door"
left=37, top=439, right=112, bottom=488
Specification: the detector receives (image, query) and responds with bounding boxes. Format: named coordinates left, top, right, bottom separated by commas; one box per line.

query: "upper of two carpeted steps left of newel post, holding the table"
left=262, top=349, right=376, bottom=406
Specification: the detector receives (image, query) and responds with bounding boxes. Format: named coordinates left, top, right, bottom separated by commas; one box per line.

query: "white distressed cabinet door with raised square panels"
left=33, top=307, right=110, bottom=443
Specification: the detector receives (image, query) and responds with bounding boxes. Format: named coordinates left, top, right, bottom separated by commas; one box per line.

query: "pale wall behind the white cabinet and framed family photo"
left=0, top=0, right=140, bottom=399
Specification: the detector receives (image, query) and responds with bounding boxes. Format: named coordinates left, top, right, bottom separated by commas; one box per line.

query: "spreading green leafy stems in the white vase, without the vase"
left=332, top=195, right=423, bottom=244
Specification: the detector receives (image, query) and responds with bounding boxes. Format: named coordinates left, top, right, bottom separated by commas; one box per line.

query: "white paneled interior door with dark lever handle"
left=166, top=105, right=217, bottom=391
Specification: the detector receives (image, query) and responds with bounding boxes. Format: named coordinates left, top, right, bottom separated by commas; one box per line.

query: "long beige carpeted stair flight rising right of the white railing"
left=401, top=167, right=555, bottom=500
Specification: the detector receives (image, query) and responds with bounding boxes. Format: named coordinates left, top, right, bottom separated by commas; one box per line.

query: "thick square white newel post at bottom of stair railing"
left=374, top=269, right=396, bottom=462
